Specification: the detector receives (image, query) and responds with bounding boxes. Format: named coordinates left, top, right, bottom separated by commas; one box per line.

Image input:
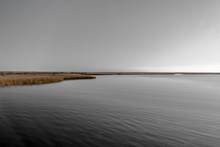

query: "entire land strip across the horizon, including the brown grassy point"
left=0, top=71, right=220, bottom=87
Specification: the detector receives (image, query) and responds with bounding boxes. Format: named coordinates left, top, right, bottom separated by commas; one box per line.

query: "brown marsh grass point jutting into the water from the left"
left=0, top=73, right=96, bottom=87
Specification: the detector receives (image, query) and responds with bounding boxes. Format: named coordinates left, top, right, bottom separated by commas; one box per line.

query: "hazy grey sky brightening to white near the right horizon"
left=0, top=0, right=220, bottom=72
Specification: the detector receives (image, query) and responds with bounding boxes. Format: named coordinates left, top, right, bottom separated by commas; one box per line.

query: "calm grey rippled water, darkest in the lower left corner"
left=0, top=76, right=220, bottom=147
